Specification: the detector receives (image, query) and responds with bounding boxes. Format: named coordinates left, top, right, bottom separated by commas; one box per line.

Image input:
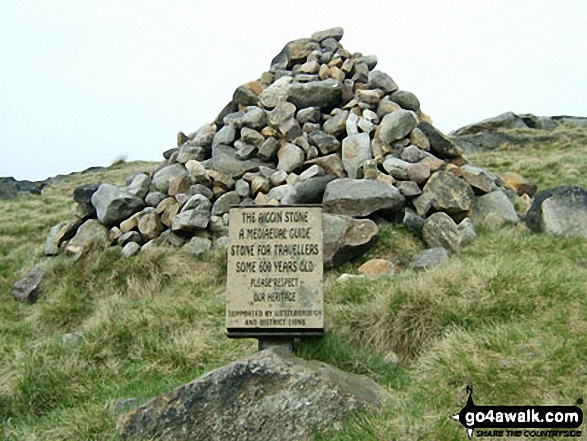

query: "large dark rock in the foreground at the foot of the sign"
left=117, top=349, right=388, bottom=441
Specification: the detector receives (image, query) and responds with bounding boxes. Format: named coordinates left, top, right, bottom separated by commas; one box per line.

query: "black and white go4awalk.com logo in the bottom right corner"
left=451, top=386, right=583, bottom=439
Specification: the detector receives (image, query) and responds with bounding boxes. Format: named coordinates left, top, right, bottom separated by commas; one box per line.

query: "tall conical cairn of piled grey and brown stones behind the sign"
left=46, top=28, right=519, bottom=266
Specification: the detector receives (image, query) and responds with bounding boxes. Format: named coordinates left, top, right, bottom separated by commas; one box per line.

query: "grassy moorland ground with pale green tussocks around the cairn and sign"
left=0, top=129, right=587, bottom=441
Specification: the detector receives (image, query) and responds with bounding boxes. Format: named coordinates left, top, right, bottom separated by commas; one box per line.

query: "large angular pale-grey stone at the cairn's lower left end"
left=92, top=184, right=145, bottom=227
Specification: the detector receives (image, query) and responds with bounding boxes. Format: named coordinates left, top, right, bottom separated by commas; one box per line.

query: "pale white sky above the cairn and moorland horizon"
left=0, top=0, right=587, bottom=180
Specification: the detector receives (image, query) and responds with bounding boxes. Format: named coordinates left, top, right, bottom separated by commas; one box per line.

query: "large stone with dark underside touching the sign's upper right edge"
left=322, top=213, right=379, bottom=268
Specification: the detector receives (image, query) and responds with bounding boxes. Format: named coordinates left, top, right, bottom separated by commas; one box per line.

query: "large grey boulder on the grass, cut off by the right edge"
left=526, top=185, right=587, bottom=237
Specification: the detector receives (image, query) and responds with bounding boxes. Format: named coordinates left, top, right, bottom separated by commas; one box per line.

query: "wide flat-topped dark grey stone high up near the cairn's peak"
left=287, top=78, right=342, bottom=109
